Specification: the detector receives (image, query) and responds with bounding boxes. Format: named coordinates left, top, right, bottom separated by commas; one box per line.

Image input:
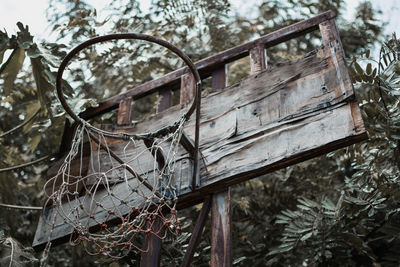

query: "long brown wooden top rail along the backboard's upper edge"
left=80, top=11, right=335, bottom=119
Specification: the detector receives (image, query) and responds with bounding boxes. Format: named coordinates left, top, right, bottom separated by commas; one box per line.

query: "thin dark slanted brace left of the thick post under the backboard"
left=181, top=196, right=211, bottom=267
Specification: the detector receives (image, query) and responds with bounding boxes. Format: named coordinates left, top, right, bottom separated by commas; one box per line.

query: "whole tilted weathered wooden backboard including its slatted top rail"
left=33, top=12, right=367, bottom=249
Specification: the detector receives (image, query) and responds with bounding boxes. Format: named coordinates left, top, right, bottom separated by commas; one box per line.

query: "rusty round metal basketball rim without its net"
left=56, top=33, right=201, bottom=139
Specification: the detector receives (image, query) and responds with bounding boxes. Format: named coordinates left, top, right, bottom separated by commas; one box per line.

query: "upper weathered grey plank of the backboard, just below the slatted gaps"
left=121, top=43, right=354, bottom=138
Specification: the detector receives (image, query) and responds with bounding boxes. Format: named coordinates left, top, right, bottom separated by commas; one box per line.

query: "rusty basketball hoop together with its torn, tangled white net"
left=45, top=33, right=201, bottom=258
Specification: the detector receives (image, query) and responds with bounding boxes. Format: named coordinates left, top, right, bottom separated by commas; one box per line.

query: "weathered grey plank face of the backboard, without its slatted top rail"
left=34, top=42, right=366, bottom=248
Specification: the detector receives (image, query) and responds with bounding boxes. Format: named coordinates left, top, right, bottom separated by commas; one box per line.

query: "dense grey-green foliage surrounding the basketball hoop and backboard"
left=0, top=0, right=400, bottom=266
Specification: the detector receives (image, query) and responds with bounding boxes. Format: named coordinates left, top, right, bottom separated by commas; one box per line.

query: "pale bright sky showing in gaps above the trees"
left=0, top=0, right=400, bottom=41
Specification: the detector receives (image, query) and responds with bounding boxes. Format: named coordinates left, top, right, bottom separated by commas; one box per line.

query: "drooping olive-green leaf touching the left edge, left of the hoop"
left=0, top=48, right=25, bottom=96
